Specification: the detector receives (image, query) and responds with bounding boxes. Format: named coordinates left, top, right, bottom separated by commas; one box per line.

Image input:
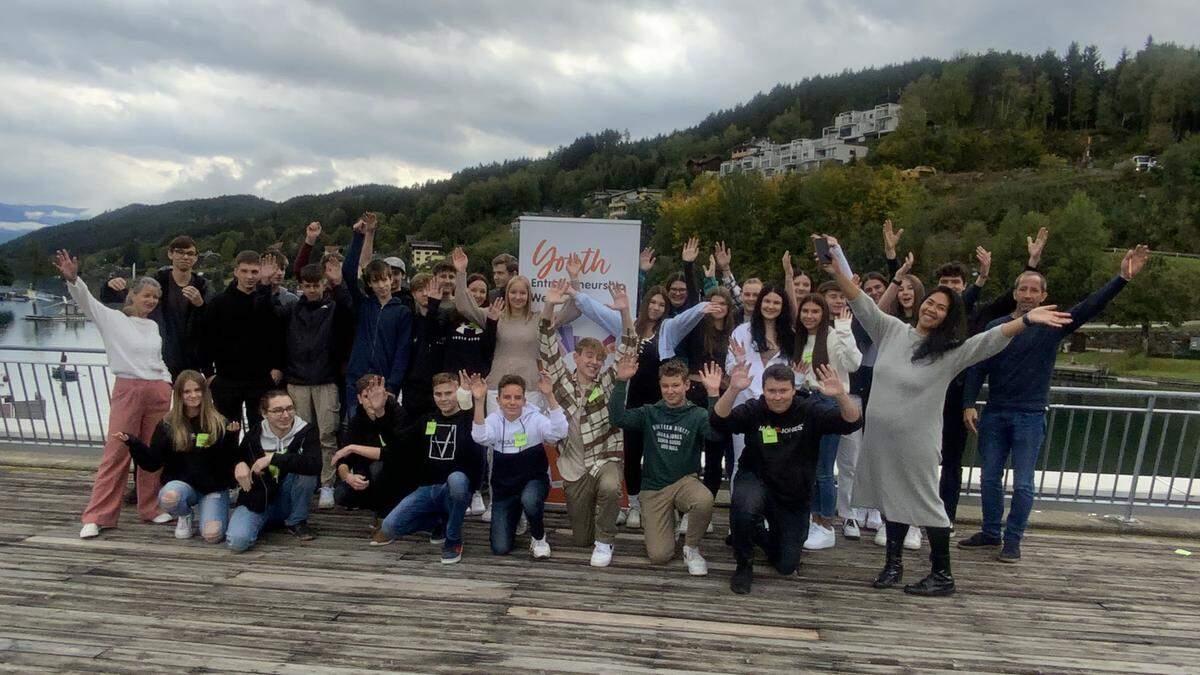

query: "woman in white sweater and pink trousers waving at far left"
left=54, top=250, right=172, bottom=539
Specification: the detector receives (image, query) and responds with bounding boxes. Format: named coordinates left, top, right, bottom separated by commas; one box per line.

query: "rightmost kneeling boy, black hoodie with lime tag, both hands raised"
left=704, top=362, right=863, bottom=593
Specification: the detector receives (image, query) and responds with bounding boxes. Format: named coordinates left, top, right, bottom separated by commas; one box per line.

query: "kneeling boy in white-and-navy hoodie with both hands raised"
left=470, top=372, right=568, bottom=558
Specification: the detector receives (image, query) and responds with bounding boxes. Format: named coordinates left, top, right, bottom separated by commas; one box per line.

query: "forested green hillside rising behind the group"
left=0, top=40, right=1200, bottom=329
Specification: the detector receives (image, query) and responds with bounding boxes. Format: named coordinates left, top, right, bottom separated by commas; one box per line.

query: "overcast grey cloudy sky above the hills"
left=0, top=0, right=1200, bottom=219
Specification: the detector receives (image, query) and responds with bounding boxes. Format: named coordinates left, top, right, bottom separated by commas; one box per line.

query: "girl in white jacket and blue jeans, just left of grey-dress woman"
left=793, top=293, right=863, bottom=550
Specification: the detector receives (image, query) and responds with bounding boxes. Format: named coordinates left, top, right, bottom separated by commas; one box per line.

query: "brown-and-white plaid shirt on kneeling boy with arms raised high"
left=539, top=318, right=637, bottom=482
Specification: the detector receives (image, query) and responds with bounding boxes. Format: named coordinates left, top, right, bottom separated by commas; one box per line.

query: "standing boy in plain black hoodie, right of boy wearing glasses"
left=199, top=251, right=284, bottom=429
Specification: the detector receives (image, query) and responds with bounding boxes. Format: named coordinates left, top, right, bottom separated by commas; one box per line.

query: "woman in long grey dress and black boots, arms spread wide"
left=824, top=242, right=1070, bottom=596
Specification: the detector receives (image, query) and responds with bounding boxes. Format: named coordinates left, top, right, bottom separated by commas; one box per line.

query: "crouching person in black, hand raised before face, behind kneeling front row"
left=330, top=374, right=416, bottom=535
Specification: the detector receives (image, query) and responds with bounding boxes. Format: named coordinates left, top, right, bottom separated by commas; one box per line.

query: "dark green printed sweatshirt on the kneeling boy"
left=608, top=382, right=719, bottom=490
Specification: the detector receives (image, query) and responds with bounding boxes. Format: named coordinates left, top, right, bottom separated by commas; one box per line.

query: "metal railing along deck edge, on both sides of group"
left=0, top=346, right=1200, bottom=519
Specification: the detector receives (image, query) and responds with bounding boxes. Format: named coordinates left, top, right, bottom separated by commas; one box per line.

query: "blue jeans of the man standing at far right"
left=979, top=407, right=1046, bottom=543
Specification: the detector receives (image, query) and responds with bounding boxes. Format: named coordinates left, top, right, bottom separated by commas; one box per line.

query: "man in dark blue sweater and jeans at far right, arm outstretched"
left=959, top=245, right=1150, bottom=562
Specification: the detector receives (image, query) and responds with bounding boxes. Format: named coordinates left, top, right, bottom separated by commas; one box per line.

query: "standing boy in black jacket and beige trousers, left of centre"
left=264, top=255, right=354, bottom=508
